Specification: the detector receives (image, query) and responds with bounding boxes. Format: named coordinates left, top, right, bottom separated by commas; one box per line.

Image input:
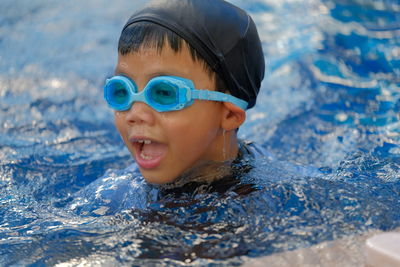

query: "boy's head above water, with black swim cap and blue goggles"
left=105, top=0, right=264, bottom=184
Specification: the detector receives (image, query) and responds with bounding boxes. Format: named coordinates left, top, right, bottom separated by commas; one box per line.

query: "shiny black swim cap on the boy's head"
left=123, top=0, right=265, bottom=108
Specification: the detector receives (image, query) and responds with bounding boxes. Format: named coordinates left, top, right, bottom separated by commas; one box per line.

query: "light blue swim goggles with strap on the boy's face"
left=104, top=75, right=248, bottom=112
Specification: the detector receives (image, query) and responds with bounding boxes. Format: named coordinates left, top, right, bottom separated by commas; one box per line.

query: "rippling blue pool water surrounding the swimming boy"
left=0, top=0, right=400, bottom=266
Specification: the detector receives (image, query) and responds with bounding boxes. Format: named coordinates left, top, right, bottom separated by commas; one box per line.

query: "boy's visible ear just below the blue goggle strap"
left=221, top=102, right=246, bottom=131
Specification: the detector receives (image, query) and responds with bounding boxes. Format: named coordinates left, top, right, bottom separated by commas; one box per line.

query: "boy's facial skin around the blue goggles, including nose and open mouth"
left=115, top=45, right=228, bottom=184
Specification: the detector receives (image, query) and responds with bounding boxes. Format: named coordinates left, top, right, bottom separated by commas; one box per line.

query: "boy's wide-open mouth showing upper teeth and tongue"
left=132, top=139, right=167, bottom=169
